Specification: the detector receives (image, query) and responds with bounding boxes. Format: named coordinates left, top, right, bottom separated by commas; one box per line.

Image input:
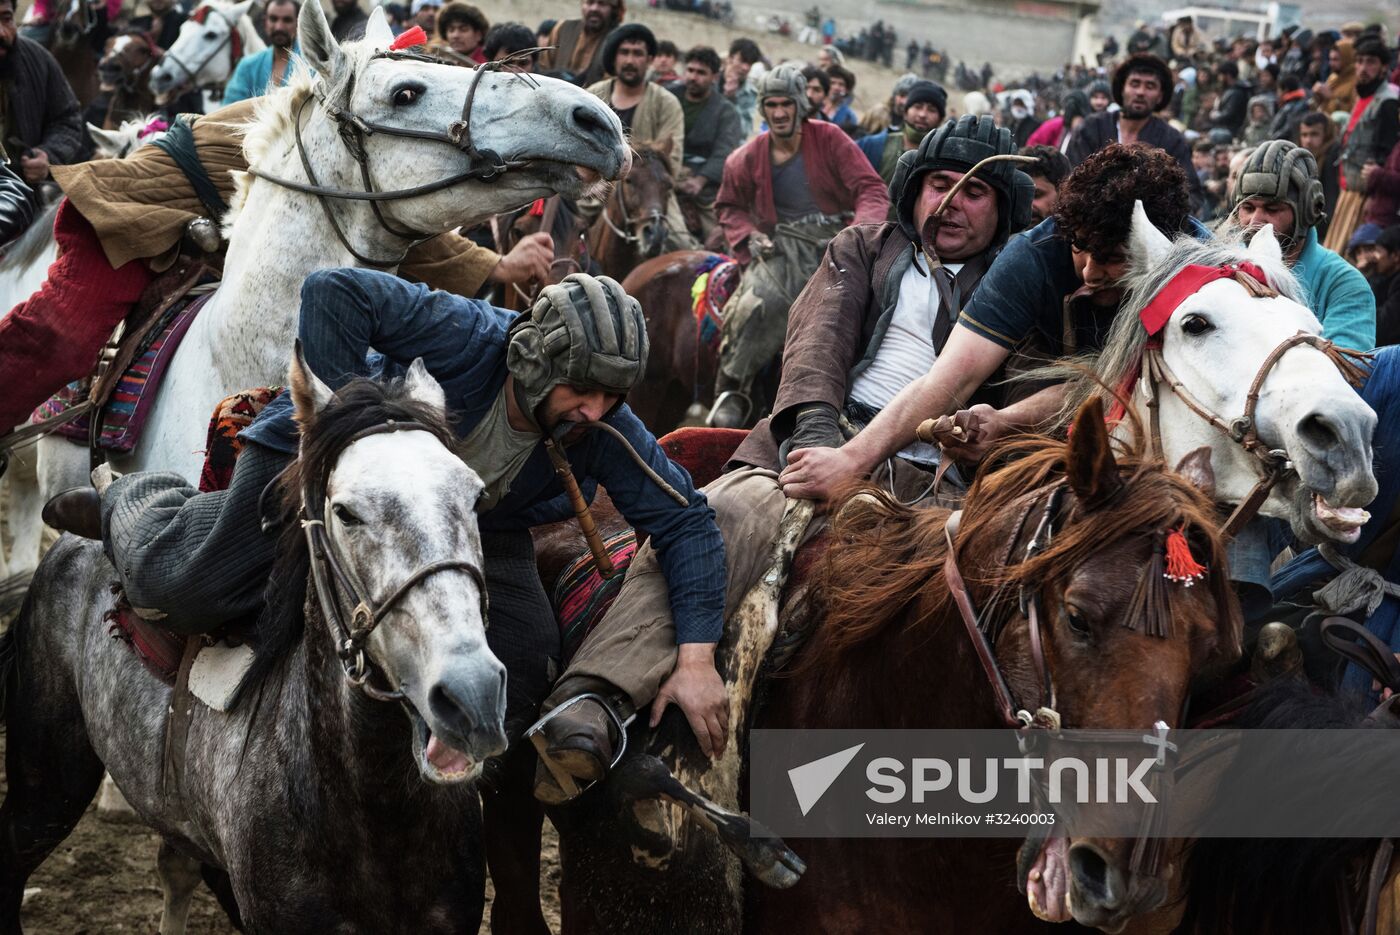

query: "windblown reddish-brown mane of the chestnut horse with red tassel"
left=804, top=433, right=1243, bottom=677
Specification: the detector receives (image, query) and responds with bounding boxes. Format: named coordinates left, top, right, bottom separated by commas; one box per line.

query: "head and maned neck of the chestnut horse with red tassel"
left=804, top=405, right=1240, bottom=931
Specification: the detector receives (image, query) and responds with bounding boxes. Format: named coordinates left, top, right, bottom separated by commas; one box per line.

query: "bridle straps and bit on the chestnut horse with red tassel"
left=944, top=484, right=1176, bottom=876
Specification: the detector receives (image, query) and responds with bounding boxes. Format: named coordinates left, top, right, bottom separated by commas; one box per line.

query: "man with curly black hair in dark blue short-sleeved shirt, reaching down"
left=780, top=143, right=1210, bottom=498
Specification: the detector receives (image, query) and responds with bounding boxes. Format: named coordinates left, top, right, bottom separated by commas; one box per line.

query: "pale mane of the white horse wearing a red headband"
left=1052, top=227, right=1309, bottom=433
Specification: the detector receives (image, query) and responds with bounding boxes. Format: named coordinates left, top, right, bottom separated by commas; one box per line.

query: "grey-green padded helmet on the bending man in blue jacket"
left=505, top=273, right=648, bottom=414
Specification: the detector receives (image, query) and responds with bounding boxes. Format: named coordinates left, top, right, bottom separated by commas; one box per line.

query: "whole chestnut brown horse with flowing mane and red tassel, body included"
left=540, top=403, right=1240, bottom=935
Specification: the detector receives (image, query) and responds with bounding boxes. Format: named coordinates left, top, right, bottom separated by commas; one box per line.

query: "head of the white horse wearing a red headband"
left=1065, top=202, right=1376, bottom=543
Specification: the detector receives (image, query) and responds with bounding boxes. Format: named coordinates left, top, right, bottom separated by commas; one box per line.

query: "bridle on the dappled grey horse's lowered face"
left=301, top=421, right=487, bottom=701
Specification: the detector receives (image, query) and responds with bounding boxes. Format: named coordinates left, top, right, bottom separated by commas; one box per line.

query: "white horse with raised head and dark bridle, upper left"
left=11, top=3, right=630, bottom=590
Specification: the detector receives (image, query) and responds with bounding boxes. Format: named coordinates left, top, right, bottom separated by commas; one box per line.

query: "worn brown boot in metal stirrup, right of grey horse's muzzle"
left=526, top=694, right=622, bottom=805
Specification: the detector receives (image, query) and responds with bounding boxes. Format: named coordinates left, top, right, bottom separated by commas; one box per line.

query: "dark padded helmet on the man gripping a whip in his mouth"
left=889, top=113, right=1036, bottom=248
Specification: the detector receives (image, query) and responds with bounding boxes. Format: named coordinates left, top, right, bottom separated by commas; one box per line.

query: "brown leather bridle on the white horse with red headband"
left=1141, top=332, right=1371, bottom=537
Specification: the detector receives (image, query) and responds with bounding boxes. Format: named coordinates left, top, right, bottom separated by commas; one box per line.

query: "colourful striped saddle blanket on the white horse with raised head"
left=31, top=294, right=211, bottom=454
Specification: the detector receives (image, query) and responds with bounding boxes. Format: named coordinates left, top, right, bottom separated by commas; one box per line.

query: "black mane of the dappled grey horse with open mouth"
left=238, top=378, right=456, bottom=697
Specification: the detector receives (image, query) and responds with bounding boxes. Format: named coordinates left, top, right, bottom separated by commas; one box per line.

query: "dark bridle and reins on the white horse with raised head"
left=248, top=49, right=532, bottom=269
